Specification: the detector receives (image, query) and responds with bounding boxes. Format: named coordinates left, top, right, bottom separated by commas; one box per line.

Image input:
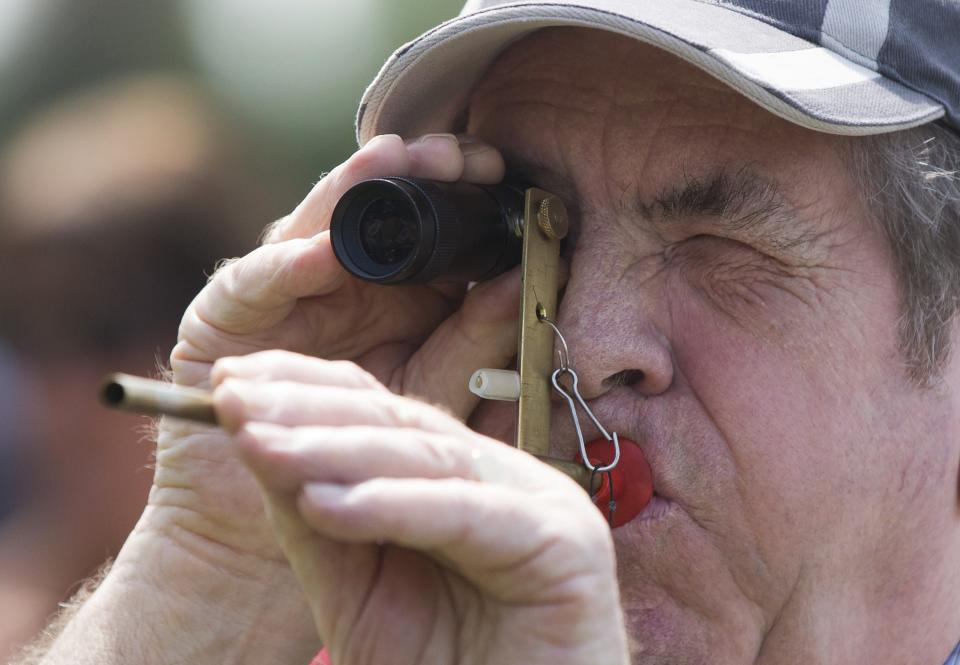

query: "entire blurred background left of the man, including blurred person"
left=0, top=0, right=461, bottom=662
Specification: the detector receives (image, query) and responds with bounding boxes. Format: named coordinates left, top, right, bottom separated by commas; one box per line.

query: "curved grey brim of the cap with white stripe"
left=357, top=0, right=944, bottom=145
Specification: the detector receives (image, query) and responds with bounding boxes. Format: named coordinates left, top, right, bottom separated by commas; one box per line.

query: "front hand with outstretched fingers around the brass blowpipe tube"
left=213, top=352, right=628, bottom=665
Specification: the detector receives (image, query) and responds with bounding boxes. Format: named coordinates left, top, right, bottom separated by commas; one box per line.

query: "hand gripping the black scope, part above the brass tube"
left=171, top=134, right=519, bottom=400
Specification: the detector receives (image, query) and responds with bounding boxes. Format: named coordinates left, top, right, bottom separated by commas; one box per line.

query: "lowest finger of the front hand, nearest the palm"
left=297, top=478, right=614, bottom=600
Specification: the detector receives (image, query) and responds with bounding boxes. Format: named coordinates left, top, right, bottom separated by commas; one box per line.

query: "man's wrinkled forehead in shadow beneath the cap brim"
left=467, top=27, right=840, bottom=179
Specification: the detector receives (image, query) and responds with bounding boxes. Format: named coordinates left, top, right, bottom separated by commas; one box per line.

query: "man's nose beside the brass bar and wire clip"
left=558, top=262, right=673, bottom=400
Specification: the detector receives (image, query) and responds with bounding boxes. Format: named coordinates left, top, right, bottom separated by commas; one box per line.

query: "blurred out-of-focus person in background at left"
left=0, top=74, right=267, bottom=660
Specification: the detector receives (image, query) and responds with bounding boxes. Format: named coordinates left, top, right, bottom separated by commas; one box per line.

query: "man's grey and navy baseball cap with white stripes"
left=357, top=0, right=960, bottom=144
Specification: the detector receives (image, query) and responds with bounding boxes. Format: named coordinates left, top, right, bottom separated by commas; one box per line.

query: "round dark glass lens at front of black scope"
left=359, top=198, right=420, bottom=266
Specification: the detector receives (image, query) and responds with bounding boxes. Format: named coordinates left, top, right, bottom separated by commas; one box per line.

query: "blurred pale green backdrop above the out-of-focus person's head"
left=0, top=0, right=462, bottom=187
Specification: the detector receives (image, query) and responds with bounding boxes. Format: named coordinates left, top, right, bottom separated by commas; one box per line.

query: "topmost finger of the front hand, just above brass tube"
left=210, top=350, right=386, bottom=392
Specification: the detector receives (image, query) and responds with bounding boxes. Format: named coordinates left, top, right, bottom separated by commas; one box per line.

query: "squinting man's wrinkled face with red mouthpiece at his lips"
left=469, top=29, right=956, bottom=665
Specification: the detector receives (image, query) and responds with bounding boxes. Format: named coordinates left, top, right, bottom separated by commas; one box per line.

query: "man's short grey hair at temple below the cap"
left=853, top=123, right=960, bottom=385
